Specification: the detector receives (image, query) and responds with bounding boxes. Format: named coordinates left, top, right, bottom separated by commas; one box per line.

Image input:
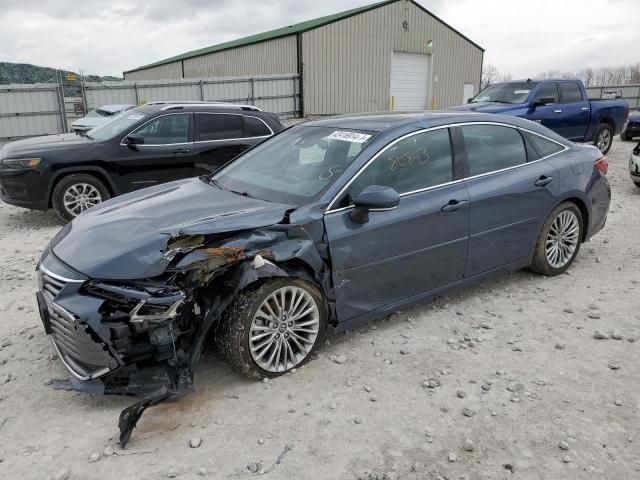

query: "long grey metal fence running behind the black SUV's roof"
left=83, top=75, right=300, bottom=117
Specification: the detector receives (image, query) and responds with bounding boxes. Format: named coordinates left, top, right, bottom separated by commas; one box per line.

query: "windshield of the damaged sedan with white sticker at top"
left=212, top=126, right=375, bottom=206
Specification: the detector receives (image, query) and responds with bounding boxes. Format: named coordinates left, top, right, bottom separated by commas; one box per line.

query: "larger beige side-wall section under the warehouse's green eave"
left=184, top=35, right=298, bottom=78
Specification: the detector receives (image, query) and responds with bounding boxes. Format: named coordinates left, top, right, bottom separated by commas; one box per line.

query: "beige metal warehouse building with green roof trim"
left=124, top=0, right=484, bottom=115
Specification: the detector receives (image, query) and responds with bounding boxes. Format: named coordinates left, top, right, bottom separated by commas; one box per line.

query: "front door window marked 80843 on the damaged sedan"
left=340, top=128, right=453, bottom=207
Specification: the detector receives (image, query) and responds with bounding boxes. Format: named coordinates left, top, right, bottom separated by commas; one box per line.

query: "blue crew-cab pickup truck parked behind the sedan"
left=451, top=80, right=629, bottom=153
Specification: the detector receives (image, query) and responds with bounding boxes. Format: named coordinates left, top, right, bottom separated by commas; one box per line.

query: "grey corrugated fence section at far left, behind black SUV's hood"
left=0, top=85, right=64, bottom=143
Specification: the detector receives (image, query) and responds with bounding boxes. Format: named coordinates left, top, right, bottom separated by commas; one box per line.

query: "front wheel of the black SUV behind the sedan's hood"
left=51, top=173, right=111, bottom=222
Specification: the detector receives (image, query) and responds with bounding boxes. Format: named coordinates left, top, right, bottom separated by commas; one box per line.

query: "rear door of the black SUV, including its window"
left=194, top=112, right=273, bottom=175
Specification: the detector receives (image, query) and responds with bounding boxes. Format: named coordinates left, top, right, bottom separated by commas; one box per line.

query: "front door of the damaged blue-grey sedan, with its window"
left=325, top=128, right=469, bottom=321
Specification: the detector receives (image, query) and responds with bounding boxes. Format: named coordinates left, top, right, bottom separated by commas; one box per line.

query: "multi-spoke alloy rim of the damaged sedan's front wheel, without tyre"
left=249, top=286, right=320, bottom=373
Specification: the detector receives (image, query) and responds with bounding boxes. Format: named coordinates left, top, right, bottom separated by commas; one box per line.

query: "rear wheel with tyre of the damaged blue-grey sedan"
left=530, top=202, right=584, bottom=277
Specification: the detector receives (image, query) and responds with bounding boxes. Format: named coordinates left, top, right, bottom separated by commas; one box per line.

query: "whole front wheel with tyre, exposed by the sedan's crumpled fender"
left=218, top=278, right=327, bottom=379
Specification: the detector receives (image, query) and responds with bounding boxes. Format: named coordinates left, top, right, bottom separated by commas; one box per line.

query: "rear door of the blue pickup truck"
left=554, top=81, right=590, bottom=140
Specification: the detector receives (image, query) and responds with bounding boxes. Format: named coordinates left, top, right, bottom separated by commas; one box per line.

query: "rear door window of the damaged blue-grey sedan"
left=460, top=125, right=527, bottom=177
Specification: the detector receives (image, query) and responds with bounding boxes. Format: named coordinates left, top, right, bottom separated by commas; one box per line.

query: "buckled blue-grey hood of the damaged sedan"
left=52, top=178, right=294, bottom=280
